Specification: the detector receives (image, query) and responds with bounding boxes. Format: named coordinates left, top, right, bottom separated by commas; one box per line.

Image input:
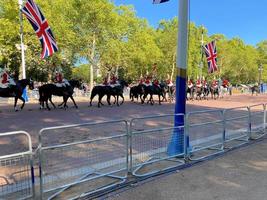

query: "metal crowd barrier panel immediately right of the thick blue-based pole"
left=186, top=110, right=224, bottom=160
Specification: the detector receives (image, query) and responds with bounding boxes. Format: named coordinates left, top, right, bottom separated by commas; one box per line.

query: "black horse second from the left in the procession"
left=39, top=80, right=81, bottom=110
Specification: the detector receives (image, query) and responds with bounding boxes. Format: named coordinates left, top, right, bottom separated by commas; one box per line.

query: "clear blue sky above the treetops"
left=114, top=0, right=267, bottom=45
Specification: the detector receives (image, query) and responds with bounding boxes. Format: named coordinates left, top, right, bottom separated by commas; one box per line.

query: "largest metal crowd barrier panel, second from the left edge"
left=39, top=120, right=128, bottom=199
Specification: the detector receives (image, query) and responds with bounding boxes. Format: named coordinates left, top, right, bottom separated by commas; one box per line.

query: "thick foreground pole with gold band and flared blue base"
left=167, top=0, right=189, bottom=155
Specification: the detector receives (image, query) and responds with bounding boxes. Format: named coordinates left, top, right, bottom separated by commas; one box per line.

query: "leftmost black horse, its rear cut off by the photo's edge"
left=0, top=79, right=34, bottom=111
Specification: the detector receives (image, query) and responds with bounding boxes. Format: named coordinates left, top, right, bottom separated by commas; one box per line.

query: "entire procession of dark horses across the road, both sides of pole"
left=0, top=79, right=264, bottom=111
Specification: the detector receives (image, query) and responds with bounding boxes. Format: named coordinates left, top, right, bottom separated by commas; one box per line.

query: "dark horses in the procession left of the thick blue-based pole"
left=0, top=79, right=175, bottom=111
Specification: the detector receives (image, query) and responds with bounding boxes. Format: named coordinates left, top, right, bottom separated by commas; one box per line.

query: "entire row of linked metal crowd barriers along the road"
left=0, top=104, right=266, bottom=199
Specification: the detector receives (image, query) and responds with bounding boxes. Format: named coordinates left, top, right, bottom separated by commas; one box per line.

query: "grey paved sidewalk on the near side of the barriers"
left=105, top=137, right=267, bottom=200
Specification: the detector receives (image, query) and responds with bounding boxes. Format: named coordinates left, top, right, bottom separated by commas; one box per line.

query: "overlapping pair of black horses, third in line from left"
left=90, top=80, right=128, bottom=107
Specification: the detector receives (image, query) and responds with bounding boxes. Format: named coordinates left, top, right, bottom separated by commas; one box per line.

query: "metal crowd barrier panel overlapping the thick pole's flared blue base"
left=129, top=114, right=185, bottom=177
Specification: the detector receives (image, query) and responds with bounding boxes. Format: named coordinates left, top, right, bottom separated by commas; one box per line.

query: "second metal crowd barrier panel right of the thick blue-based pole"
left=223, top=107, right=250, bottom=148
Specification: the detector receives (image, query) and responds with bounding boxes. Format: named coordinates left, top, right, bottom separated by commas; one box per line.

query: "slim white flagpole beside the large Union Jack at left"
left=18, top=0, right=26, bottom=79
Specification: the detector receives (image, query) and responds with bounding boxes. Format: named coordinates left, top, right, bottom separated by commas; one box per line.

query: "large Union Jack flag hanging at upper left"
left=22, top=0, right=58, bottom=58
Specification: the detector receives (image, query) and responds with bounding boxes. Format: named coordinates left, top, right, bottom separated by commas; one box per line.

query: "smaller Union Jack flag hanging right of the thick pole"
left=203, top=41, right=218, bottom=73
